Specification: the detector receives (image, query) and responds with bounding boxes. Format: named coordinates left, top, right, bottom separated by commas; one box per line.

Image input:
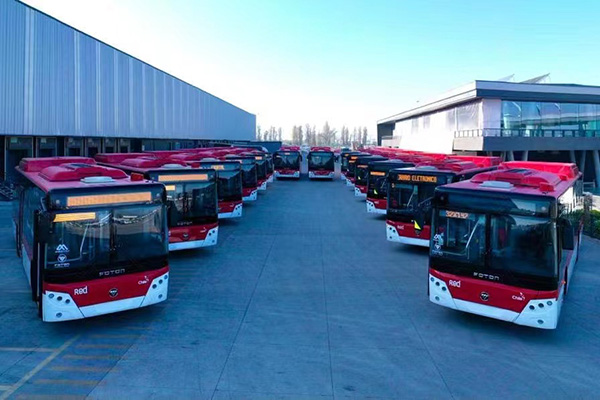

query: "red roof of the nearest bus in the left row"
left=17, top=157, right=157, bottom=192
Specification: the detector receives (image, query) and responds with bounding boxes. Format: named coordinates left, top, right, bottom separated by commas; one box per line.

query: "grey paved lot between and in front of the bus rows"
left=0, top=176, right=600, bottom=399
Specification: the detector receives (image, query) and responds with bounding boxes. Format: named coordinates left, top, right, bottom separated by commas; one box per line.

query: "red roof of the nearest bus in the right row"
left=444, top=161, right=581, bottom=198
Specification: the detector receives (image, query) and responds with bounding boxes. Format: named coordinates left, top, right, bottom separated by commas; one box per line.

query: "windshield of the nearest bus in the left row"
left=45, top=205, right=168, bottom=281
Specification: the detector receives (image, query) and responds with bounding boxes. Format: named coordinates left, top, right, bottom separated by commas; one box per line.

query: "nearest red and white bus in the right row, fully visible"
left=429, top=161, right=583, bottom=329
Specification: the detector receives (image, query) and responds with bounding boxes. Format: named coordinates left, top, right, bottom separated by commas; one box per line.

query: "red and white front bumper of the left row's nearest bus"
left=41, top=267, right=169, bottom=322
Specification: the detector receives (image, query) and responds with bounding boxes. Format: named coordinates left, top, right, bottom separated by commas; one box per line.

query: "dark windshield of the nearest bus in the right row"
left=430, top=210, right=557, bottom=290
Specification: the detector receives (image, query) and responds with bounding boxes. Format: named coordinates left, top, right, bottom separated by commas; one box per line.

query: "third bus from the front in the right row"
left=367, top=160, right=414, bottom=214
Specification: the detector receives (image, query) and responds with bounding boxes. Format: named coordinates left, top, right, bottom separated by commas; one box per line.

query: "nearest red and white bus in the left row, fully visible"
left=15, top=157, right=169, bottom=322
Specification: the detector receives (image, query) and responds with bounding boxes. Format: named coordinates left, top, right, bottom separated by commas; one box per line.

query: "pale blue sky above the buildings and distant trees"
left=25, top=0, right=600, bottom=139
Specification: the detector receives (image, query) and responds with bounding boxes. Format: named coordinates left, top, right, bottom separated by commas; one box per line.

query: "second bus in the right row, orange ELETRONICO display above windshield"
left=386, top=157, right=500, bottom=247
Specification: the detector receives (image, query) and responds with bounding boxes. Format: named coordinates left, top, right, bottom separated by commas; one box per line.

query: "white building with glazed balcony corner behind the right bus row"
left=377, top=79, right=600, bottom=187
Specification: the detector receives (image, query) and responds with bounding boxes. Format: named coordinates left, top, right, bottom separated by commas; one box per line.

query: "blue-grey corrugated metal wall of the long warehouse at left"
left=0, top=0, right=256, bottom=140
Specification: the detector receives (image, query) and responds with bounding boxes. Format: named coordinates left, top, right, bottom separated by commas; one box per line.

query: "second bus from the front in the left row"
left=95, top=153, right=219, bottom=251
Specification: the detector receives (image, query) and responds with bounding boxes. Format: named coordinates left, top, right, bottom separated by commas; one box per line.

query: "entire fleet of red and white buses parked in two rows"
left=13, top=146, right=583, bottom=329
